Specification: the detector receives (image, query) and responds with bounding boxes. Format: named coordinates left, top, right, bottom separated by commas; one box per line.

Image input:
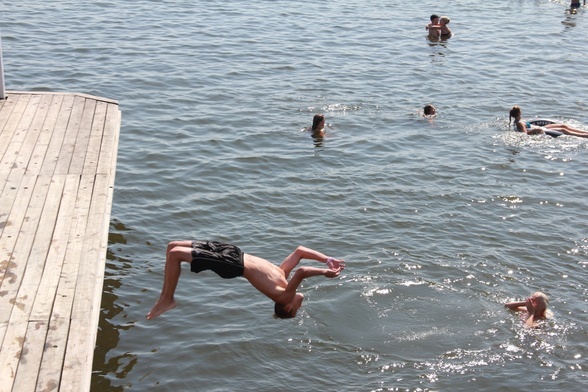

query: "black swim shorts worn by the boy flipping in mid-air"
left=190, top=241, right=245, bottom=279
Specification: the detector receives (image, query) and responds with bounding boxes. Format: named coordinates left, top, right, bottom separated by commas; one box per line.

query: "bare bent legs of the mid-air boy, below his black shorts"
left=147, top=241, right=192, bottom=319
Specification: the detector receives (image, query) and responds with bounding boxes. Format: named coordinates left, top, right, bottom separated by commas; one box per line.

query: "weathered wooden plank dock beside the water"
left=0, top=91, right=121, bottom=392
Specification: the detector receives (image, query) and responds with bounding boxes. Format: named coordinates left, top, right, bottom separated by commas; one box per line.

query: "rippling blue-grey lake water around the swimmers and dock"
left=1, top=0, right=588, bottom=391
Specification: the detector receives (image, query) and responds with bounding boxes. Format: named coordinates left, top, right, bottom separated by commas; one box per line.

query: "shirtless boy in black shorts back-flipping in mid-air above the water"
left=147, top=240, right=345, bottom=319
